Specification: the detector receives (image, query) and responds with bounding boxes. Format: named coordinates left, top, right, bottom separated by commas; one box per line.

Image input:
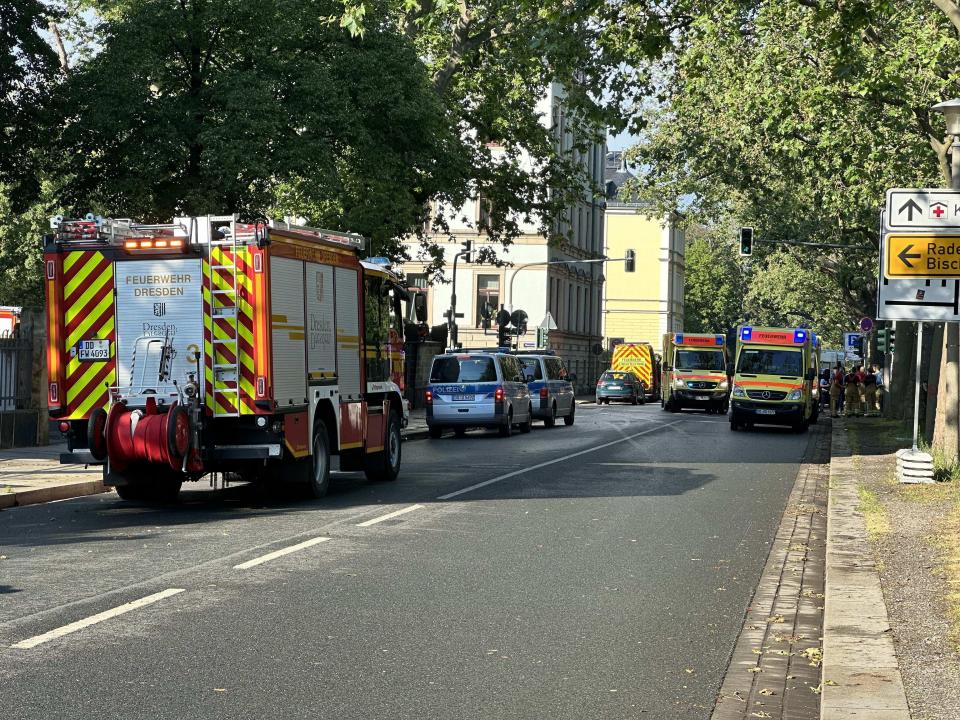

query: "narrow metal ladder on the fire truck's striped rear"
left=207, top=218, right=240, bottom=417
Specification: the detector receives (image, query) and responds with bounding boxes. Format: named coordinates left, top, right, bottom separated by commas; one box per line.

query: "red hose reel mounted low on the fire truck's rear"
left=104, top=397, right=190, bottom=471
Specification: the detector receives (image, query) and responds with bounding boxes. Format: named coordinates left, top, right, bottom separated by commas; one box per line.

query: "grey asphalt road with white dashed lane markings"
left=0, top=405, right=807, bottom=720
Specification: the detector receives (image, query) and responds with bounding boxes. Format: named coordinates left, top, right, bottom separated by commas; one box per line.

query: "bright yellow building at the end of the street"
left=603, top=152, right=684, bottom=352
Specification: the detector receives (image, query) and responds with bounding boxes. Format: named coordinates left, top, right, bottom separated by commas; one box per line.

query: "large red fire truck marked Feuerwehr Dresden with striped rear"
left=44, top=216, right=409, bottom=499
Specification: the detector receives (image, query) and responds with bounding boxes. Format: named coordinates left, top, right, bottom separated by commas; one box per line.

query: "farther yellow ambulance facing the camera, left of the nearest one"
left=660, top=333, right=730, bottom=413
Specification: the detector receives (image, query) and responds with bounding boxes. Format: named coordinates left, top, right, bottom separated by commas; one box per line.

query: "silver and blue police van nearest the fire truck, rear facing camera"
left=424, top=351, right=533, bottom=439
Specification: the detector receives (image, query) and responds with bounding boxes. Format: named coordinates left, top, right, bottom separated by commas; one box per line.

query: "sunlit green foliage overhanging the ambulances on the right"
left=628, top=0, right=960, bottom=333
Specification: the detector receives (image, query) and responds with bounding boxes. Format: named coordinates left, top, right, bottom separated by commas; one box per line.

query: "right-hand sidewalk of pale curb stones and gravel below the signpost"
left=822, top=418, right=960, bottom=720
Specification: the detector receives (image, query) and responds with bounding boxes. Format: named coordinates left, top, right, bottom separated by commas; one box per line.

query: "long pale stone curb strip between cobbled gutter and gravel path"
left=820, top=419, right=910, bottom=720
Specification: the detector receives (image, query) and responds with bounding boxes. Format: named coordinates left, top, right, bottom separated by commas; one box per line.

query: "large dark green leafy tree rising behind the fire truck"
left=49, top=0, right=470, bottom=255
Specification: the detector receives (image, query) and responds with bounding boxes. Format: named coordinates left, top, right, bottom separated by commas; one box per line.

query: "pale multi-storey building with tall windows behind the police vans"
left=401, top=84, right=605, bottom=389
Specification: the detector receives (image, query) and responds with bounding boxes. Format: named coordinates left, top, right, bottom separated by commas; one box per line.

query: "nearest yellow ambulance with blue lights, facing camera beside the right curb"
left=730, top=325, right=817, bottom=432
